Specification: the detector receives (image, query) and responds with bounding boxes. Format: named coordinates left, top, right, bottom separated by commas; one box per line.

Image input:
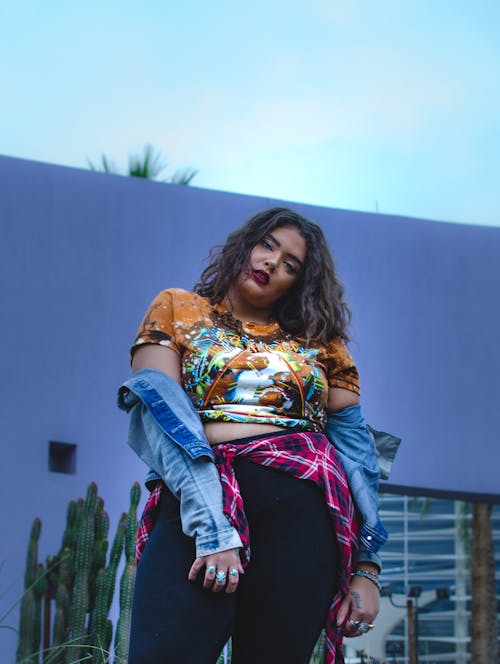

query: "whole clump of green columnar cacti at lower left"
left=17, top=483, right=140, bottom=664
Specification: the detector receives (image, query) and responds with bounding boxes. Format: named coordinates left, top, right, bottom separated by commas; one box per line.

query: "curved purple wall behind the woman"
left=0, top=158, right=500, bottom=652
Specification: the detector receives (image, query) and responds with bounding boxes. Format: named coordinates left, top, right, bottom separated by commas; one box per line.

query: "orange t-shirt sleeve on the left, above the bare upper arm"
left=131, top=290, right=181, bottom=355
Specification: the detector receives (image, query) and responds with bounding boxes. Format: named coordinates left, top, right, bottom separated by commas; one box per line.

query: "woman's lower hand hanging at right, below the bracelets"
left=337, top=576, right=380, bottom=636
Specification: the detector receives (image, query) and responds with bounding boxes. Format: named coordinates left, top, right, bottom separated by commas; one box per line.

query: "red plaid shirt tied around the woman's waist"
left=136, top=432, right=358, bottom=664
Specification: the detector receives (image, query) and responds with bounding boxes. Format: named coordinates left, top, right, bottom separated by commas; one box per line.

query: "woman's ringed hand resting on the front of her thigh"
left=188, top=549, right=244, bottom=593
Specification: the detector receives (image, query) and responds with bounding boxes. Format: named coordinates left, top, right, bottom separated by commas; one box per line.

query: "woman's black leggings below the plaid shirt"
left=128, top=459, right=338, bottom=664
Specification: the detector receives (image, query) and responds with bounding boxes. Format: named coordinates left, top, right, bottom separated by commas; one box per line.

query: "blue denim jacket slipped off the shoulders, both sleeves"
left=118, top=369, right=399, bottom=566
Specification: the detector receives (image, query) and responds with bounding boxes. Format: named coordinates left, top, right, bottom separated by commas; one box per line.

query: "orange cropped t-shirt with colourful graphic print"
left=132, top=288, right=359, bottom=431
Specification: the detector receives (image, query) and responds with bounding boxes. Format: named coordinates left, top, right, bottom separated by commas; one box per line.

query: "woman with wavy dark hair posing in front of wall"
left=122, top=208, right=385, bottom=664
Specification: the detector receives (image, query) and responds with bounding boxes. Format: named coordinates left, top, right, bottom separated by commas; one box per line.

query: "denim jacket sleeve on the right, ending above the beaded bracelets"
left=326, top=405, right=401, bottom=568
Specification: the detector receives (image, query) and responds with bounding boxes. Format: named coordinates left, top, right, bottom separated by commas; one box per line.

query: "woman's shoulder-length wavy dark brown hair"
left=194, top=207, right=351, bottom=343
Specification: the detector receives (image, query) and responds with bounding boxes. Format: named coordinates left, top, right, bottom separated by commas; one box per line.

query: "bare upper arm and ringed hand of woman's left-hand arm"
left=132, top=344, right=243, bottom=593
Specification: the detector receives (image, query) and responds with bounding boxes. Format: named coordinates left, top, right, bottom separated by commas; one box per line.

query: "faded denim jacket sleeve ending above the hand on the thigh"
left=118, top=369, right=241, bottom=556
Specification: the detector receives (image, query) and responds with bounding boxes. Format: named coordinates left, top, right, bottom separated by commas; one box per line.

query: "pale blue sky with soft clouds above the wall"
left=0, top=0, right=500, bottom=226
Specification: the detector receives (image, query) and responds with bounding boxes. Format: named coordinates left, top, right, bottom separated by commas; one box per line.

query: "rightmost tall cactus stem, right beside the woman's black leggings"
left=115, top=482, right=141, bottom=664
